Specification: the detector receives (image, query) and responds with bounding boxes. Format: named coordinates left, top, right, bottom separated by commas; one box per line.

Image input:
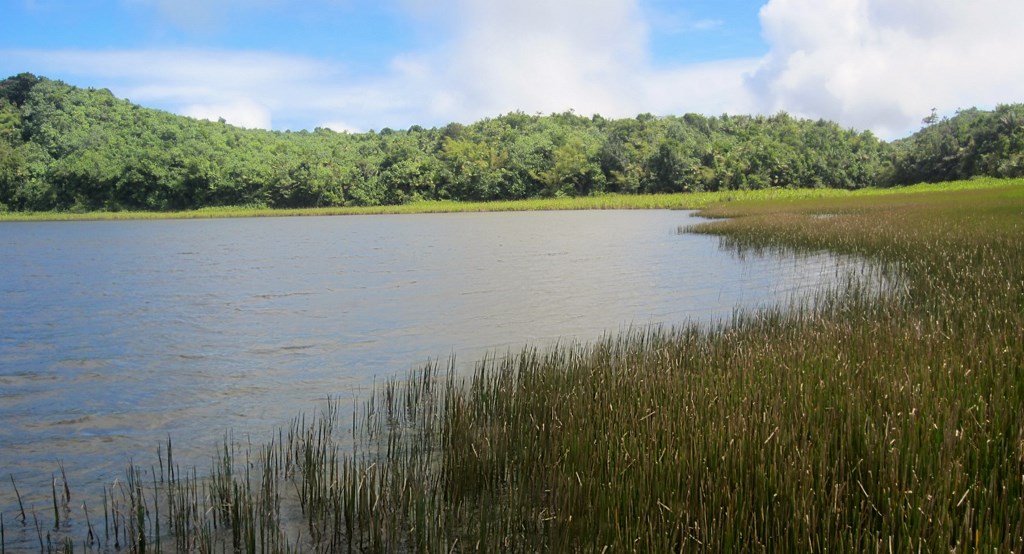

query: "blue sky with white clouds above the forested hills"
left=0, top=0, right=1024, bottom=139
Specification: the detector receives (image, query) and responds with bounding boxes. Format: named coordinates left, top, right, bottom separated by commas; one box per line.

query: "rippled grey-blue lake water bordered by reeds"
left=0, top=211, right=856, bottom=521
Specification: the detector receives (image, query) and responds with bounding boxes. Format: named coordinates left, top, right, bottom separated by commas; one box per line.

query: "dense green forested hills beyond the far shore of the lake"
left=0, top=74, right=1024, bottom=211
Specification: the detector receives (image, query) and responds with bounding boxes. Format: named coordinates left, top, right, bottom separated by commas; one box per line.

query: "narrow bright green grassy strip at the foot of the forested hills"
left=0, top=178, right=1021, bottom=221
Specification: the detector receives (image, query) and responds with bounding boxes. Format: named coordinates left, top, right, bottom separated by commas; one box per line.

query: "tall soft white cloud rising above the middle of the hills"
left=434, top=0, right=647, bottom=115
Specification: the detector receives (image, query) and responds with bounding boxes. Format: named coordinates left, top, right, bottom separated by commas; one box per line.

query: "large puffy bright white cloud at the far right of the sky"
left=748, top=0, right=1024, bottom=137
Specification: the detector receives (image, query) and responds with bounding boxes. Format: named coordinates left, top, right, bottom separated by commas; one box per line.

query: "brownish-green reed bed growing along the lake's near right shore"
left=0, top=180, right=1024, bottom=552
